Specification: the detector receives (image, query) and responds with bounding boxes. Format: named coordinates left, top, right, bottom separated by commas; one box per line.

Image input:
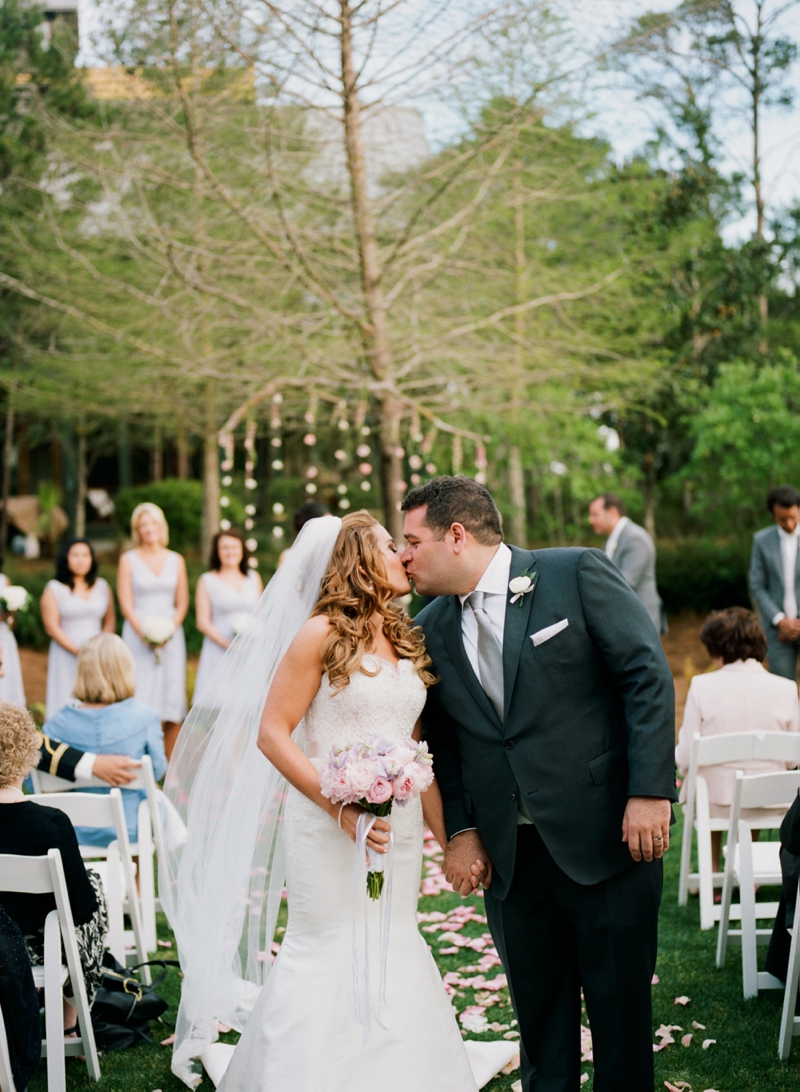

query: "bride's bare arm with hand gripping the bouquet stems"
left=259, top=615, right=390, bottom=852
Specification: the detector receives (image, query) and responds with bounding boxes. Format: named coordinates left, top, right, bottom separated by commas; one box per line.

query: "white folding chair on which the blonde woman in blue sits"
left=31, top=755, right=164, bottom=952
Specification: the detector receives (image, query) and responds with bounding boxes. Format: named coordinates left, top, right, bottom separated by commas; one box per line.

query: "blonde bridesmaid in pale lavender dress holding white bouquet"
left=117, top=502, right=189, bottom=759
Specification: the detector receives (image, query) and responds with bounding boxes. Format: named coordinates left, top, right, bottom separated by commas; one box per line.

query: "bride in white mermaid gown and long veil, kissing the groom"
left=162, top=512, right=509, bottom=1092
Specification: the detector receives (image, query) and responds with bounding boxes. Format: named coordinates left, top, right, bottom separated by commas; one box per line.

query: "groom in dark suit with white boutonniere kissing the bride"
left=402, top=477, right=677, bottom=1092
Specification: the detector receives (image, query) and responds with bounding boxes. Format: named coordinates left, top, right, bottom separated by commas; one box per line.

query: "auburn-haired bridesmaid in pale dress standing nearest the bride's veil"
left=193, top=529, right=262, bottom=701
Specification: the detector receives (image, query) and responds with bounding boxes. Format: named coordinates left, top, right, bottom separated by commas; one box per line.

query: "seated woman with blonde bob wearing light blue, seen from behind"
left=45, top=633, right=167, bottom=845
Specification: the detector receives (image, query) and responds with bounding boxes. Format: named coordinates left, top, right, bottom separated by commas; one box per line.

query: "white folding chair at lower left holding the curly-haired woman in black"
left=0, top=850, right=100, bottom=1092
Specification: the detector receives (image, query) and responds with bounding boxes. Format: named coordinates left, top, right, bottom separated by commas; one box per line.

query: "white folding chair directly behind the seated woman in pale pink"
left=717, top=770, right=800, bottom=997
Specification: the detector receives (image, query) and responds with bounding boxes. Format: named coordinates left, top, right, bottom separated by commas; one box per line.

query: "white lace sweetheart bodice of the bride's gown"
left=305, top=653, right=425, bottom=759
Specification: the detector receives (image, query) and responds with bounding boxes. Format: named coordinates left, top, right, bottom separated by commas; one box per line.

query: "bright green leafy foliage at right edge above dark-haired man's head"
left=685, top=353, right=800, bottom=533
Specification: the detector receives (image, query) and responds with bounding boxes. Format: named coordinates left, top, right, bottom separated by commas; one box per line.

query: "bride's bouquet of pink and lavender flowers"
left=320, top=736, right=433, bottom=899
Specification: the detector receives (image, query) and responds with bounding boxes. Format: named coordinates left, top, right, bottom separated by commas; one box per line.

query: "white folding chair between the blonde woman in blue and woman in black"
left=26, top=788, right=151, bottom=985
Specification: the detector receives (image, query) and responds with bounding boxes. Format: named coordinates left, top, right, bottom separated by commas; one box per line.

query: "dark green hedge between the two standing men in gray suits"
left=656, top=538, right=751, bottom=614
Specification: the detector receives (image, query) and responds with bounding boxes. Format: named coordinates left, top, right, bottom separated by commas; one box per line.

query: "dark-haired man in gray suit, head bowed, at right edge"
left=750, top=485, right=800, bottom=681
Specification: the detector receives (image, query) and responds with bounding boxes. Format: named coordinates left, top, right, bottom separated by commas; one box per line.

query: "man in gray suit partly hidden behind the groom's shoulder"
left=589, top=492, right=664, bottom=633
